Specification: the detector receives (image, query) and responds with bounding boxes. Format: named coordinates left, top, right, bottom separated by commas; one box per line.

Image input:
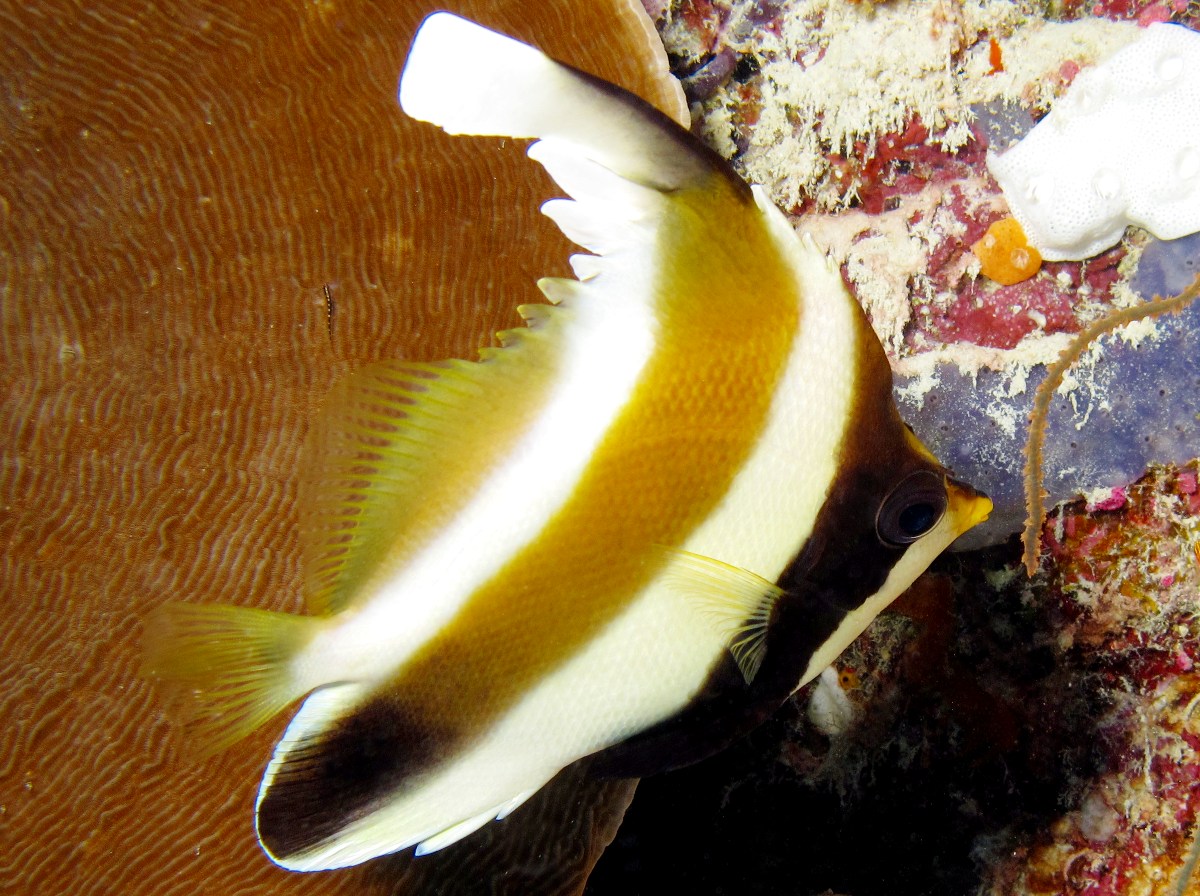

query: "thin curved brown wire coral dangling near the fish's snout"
left=1021, top=277, right=1200, bottom=577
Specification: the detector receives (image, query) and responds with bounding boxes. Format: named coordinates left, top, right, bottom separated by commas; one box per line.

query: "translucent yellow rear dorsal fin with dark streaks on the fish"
left=300, top=319, right=562, bottom=614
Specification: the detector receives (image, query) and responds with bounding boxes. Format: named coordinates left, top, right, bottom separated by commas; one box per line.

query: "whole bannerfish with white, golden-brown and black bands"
left=146, top=13, right=991, bottom=891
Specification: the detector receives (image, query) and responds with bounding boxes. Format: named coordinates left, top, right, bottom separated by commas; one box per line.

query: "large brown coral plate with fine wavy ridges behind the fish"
left=0, top=0, right=683, bottom=896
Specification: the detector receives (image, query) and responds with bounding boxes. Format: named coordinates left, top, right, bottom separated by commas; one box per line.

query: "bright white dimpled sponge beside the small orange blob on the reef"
left=988, top=24, right=1200, bottom=261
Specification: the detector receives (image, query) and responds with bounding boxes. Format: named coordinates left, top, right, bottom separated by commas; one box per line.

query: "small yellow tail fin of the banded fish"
left=143, top=603, right=320, bottom=756
